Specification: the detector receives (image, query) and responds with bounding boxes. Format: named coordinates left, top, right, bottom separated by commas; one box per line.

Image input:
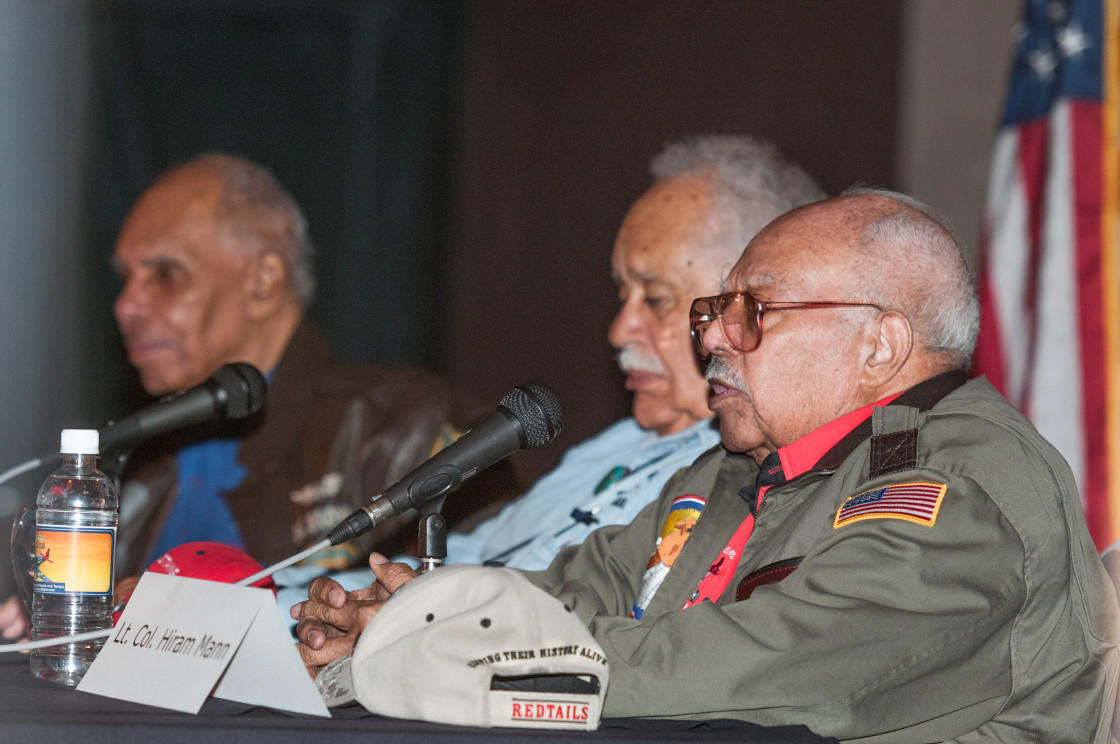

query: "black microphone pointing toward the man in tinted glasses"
left=327, top=383, right=563, bottom=545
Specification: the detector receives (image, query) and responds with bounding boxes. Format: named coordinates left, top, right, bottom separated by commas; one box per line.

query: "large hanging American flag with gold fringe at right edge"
left=973, top=0, right=1120, bottom=548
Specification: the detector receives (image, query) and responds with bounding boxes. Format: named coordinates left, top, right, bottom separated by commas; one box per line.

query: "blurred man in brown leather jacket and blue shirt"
left=0, top=155, right=520, bottom=636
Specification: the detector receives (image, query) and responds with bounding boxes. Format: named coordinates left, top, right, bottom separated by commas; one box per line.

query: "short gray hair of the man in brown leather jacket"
left=167, top=152, right=315, bottom=309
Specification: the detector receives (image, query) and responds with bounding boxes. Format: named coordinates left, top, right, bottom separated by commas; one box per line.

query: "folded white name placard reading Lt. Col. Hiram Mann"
left=77, top=573, right=330, bottom=716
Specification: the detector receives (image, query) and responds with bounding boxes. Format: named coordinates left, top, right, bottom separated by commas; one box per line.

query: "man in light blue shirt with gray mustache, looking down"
left=450, top=136, right=824, bottom=569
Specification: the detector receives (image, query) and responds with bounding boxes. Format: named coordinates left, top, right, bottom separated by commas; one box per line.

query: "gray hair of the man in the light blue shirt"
left=650, top=134, right=825, bottom=258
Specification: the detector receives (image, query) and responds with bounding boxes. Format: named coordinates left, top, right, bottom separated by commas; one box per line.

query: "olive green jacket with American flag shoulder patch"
left=529, top=375, right=1120, bottom=744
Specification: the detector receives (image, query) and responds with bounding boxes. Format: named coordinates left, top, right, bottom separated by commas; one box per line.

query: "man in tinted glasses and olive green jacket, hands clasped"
left=297, top=189, right=1120, bottom=744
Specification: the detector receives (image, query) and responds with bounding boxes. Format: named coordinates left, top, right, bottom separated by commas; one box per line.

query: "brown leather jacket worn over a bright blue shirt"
left=118, top=320, right=521, bottom=576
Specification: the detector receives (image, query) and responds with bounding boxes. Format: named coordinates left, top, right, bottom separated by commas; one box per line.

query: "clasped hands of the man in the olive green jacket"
left=291, top=552, right=417, bottom=677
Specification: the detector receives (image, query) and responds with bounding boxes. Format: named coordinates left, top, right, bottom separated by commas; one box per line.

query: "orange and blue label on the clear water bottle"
left=34, top=527, right=116, bottom=596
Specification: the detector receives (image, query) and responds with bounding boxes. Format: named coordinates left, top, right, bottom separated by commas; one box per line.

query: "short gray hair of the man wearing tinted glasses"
left=841, top=186, right=980, bottom=366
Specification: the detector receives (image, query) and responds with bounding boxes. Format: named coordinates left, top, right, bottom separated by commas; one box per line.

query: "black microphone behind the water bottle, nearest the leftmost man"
left=99, top=362, right=268, bottom=462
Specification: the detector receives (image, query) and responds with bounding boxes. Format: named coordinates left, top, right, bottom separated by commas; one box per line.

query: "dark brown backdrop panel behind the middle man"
left=445, top=0, right=902, bottom=477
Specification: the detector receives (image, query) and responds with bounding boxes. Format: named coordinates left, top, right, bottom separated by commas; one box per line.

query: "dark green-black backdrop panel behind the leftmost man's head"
left=80, top=0, right=466, bottom=416
